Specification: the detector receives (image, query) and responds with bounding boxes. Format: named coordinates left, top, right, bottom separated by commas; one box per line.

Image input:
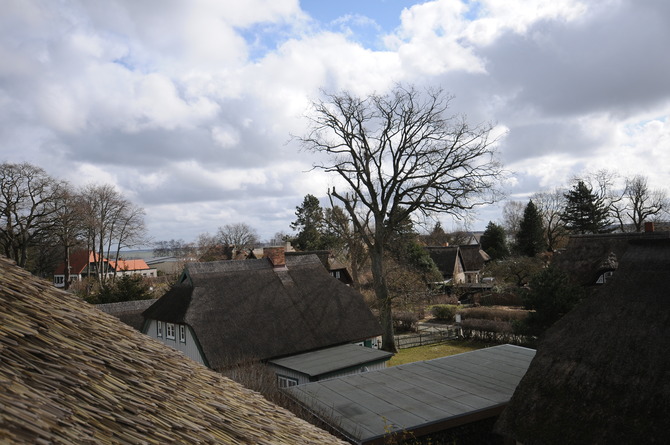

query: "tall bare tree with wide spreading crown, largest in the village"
left=300, top=85, right=501, bottom=351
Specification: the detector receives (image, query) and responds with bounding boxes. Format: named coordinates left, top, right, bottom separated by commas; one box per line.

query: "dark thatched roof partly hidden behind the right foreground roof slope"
left=552, top=232, right=670, bottom=286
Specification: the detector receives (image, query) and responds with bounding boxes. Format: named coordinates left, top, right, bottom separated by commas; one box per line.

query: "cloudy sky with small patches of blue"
left=0, top=0, right=670, bottom=245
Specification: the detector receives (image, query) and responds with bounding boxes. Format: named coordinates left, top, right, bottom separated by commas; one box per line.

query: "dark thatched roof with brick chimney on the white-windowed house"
left=144, top=255, right=381, bottom=370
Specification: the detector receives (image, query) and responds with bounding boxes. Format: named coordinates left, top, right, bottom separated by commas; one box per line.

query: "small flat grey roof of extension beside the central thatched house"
left=270, top=344, right=393, bottom=377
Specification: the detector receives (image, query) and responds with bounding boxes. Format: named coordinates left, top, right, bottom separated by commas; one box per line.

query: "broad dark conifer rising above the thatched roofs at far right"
left=562, top=181, right=612, bottom=234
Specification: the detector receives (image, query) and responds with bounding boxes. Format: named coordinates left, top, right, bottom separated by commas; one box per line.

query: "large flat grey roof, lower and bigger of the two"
left=287, top=345, right=535, bottom=443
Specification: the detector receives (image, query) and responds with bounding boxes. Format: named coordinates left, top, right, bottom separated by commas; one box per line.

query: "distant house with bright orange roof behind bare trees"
left=53, top=250, right=157, bottom=288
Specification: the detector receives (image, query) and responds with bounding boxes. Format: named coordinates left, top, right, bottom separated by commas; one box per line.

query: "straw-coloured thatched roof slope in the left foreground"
left=0, top=258, right=342, bottom=444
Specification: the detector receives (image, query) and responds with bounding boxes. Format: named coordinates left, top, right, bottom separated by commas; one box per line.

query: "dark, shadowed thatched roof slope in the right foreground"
left=498, top=239, right=670, bottom=445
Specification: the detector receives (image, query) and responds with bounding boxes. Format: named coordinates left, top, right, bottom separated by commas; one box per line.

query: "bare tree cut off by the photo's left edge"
left=0, top=162, right=64, bottom=267
